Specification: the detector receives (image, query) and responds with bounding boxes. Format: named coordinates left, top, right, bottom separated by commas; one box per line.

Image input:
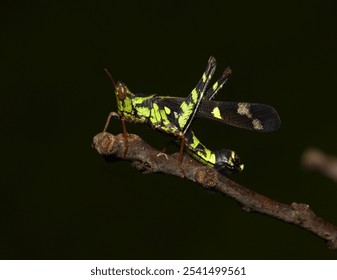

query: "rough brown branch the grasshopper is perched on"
left=93, top=132, right=337, bottom=249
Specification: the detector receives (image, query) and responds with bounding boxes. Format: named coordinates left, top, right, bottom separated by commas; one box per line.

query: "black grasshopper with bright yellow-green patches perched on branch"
left=104, top=57, right=280, bottom=174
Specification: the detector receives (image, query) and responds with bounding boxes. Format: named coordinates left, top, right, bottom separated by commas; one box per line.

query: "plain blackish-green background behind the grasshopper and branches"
left=0, top=0, right=337, bottom=259
